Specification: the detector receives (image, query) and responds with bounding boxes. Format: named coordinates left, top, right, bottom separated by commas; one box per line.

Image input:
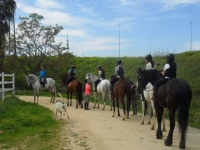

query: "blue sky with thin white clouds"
left=15, top=0, right=200, bottom=57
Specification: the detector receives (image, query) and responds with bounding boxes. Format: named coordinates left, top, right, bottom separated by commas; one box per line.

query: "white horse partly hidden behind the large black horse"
left=141, top=82, right=166, bottom=131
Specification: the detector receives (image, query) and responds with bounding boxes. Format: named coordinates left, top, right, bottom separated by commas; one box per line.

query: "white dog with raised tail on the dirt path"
left=55, top=93, right=69, bottom=120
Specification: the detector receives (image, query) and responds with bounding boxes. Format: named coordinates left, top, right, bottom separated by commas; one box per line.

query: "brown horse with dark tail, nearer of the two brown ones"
left=111, top=75, right=131, bottom=120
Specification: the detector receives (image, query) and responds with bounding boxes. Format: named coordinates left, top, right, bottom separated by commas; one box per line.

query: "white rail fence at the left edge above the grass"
left=0, top=72, right=15, bottom=101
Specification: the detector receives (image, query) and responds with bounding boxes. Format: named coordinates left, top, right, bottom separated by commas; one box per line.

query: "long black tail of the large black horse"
left=178, top=84, right=192, bottom=134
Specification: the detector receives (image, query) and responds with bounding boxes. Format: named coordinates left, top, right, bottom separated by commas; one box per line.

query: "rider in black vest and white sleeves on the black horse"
left=154, top=53, right=177, bottom=99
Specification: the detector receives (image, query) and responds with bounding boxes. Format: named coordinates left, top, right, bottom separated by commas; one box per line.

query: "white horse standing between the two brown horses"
left=85, top=73, right=112, bottom=111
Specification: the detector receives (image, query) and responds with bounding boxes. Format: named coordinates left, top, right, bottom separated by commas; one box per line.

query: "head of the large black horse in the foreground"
left=137, top=68, right=146, bottom=94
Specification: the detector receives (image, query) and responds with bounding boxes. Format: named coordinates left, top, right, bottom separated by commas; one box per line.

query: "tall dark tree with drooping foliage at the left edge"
left=0, top=0, right=16, bottom=72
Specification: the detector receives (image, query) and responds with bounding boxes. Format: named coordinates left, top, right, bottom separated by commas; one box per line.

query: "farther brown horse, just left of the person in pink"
left=60, top=74, right=83, bottom=109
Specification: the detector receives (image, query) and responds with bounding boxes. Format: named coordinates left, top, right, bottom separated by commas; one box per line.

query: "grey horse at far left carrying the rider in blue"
left=25, top=74, right=56, bottom=104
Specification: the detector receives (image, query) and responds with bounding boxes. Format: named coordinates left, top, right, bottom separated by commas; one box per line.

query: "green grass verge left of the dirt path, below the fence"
left=0, top=97, right=60, bottom=149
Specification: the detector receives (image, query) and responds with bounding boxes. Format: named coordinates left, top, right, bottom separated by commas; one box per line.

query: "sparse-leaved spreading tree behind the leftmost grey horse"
left=9, top=13, right=66, bottom=74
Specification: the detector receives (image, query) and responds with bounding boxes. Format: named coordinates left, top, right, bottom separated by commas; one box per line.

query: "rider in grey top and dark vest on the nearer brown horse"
left=110, top=59, right=125, bottom=95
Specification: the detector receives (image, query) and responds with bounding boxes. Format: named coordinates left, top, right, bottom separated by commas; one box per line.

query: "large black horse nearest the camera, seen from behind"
left=137, top=68, right=192, bottom=149
